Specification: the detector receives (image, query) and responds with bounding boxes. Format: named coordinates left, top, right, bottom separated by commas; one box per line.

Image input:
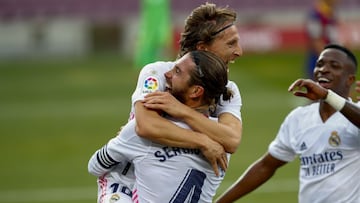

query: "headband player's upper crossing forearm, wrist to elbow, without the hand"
left=182, top=109, right=242, bottom=153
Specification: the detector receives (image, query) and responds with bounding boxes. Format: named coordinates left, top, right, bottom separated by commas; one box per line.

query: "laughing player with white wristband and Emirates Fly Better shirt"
left=217, top=44, right=360, bottom=203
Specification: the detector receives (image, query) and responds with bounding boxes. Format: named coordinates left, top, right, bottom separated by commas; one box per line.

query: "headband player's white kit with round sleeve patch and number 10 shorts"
left=89, top=61, right=242, bottom=202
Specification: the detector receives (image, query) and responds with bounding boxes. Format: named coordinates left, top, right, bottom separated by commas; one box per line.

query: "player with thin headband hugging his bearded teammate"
left=89, top=3, right=242, bottom=202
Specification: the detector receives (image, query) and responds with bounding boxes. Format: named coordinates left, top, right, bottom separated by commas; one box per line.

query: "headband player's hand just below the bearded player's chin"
left=143, top=91, right=189, bottom=118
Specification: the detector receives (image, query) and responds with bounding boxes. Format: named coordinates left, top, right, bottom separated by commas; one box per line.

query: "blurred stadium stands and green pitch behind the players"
left=0, top=0, right=360, bottom=203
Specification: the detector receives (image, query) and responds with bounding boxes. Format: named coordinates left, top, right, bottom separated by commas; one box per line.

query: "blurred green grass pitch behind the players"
left=0, top=52, right=358, bottom=203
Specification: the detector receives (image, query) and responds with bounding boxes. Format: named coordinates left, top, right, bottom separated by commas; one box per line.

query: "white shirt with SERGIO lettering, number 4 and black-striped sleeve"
left=91, top=120, right=230, bottom=203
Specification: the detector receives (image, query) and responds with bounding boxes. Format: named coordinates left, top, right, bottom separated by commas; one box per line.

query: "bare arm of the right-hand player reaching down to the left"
left=216, top=153, right=287, bottom=203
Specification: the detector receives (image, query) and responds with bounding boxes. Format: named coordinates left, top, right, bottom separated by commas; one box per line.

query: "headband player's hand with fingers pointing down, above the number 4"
left=201, top=136, right=228, bottom=176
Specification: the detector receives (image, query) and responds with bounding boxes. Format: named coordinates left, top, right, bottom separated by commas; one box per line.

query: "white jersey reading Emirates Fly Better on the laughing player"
left=269, top=103, right=360, bottom=203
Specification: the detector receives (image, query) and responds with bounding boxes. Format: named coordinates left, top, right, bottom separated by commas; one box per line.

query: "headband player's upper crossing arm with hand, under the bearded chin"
left=144, top=92, right=242, bottom=153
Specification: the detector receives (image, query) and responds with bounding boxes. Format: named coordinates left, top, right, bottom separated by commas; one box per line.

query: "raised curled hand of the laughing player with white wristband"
left=288, top=79, right=328, bottom=100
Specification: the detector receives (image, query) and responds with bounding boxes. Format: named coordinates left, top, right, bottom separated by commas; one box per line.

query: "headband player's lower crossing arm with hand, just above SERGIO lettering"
left=135, top=101, right=227, bottom=175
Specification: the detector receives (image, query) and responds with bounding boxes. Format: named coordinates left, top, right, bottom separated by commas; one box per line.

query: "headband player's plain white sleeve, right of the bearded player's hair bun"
left=215, top=81, right=242, bottom=120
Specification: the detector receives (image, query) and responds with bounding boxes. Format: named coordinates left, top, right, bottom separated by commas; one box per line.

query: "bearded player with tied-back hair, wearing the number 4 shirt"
left=88, top=51, right=232, bottom=203
